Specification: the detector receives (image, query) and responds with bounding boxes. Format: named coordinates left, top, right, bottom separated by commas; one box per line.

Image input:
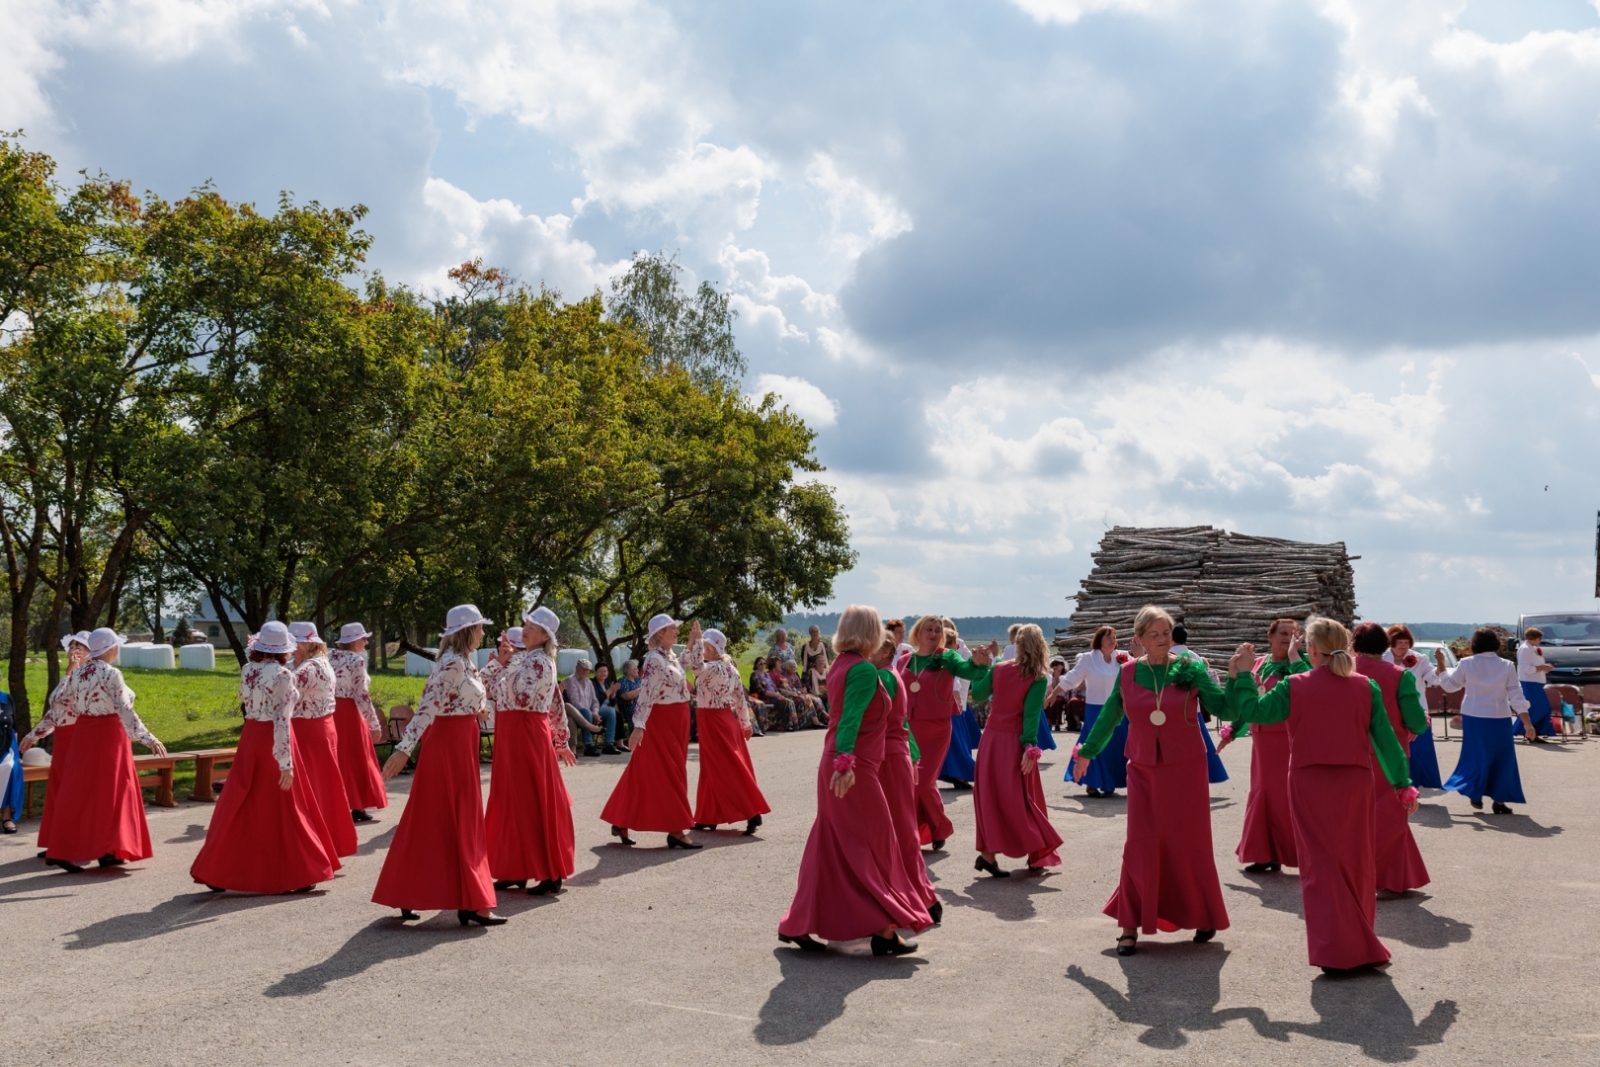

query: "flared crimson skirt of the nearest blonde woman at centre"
left=777, top=748, right=938, bottom=941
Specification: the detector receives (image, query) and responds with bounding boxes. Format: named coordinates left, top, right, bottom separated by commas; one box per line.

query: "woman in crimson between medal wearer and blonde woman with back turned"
left=1218, top=619, right=1310, bottom=873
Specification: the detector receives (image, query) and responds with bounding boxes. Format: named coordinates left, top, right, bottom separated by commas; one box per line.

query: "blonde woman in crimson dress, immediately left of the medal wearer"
left=973, top=622, right=1061, bottom=878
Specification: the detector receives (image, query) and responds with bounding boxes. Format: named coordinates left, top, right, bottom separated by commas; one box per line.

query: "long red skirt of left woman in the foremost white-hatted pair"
left=373, top=715, right=494, bottom=912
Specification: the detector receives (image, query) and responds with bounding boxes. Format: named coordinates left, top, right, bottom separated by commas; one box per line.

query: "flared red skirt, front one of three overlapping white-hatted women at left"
left=189, top=718, right=339, bottom=893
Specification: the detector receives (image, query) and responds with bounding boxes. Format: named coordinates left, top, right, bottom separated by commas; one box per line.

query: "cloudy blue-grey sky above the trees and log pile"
left=12, top=0, right=1600, bottom=621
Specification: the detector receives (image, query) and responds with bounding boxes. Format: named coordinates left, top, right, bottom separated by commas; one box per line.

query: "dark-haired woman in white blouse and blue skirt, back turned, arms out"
left=1434, top=627, right=1538, bottom=814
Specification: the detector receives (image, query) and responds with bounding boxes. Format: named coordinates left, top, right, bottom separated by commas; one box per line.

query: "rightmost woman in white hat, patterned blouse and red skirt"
left=683, top=630, right=771, bottom=837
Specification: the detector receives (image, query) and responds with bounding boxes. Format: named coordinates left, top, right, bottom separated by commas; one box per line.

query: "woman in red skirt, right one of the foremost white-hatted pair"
left=485, top=608, right=578, bottom=896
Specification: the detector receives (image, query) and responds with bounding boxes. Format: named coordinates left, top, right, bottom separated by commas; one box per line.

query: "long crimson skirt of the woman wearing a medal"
left=1104, top=755, right=1227, bottom=934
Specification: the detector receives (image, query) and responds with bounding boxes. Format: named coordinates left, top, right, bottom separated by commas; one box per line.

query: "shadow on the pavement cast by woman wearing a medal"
left=1067, top=942, right=1288, bottom=1049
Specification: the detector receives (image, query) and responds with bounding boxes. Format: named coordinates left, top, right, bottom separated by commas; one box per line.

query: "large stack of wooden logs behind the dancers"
left=1056, top=526, right=1360, bottom=665
